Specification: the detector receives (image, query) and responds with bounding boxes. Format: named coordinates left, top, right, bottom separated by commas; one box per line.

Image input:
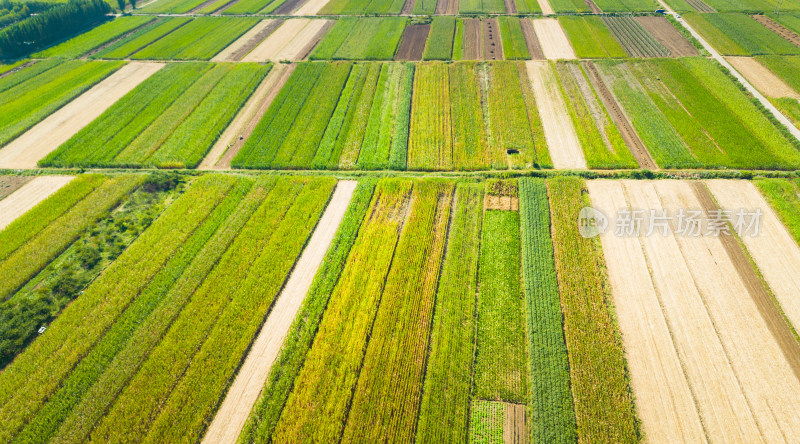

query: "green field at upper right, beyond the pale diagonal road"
left=684, top=13, right=800, bottom=55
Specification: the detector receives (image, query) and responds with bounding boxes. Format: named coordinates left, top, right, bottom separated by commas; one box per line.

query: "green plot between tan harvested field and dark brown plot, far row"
left=310, top=17, right=407, bottom=60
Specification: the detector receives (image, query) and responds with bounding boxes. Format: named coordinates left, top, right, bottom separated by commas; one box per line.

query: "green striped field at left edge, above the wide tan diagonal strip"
left=0, top=60, right=122, bottom=146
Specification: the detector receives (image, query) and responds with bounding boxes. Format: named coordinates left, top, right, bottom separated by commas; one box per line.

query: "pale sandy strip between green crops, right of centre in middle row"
left=526, top=60, right=586, bottom=169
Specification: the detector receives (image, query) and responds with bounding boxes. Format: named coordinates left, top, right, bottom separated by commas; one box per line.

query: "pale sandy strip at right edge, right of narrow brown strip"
left=706, top=180, right=800, bottom=329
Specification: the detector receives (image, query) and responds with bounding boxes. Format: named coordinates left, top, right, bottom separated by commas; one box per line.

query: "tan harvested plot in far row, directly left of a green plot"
left=242, top=19, right=333, bottom=62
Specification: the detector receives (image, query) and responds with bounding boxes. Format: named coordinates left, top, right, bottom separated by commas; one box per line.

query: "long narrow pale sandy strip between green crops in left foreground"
left=203, top=181, right=357, bottom=444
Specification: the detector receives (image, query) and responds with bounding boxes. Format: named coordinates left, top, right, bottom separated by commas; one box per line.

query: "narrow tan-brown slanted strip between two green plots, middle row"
left=198, top=63, right=297, bottom=170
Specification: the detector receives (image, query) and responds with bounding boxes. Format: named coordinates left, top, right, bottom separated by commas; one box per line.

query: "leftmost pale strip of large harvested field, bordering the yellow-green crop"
left=588, top=180, right=705, bottom=442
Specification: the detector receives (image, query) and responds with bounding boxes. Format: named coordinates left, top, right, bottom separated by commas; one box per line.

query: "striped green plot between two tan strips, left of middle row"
left=42, top=63, right=269, bottom=167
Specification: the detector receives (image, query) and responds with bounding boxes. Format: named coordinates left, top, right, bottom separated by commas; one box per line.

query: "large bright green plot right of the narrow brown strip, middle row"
left=595, top=58, right=800, bottom=169
